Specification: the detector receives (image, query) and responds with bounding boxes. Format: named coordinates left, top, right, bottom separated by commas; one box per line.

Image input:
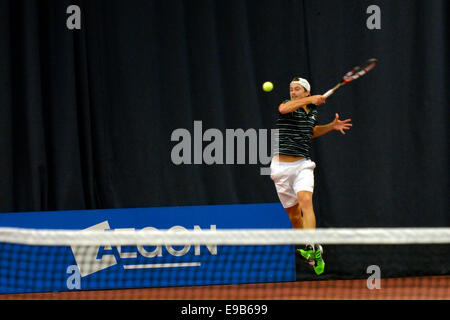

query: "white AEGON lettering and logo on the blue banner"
left=71, top=221, right=217, bottom=277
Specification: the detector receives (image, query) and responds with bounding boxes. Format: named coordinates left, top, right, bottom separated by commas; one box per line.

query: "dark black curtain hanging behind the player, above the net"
left=0, top=0, right=449, bottom=227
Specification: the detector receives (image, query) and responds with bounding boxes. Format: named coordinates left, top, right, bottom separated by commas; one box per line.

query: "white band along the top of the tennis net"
left=0, top=228, right=450, bottom=246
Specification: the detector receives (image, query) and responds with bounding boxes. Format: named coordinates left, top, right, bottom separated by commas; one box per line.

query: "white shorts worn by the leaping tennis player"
left=270, top=159, right=316, bottom=208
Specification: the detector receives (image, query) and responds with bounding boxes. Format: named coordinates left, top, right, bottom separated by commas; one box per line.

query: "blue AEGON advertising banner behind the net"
left=0, top=203, right=295, bottom=293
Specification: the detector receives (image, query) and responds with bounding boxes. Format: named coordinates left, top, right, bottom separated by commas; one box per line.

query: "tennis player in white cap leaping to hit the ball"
left=270, top=78, right=352, bottom=275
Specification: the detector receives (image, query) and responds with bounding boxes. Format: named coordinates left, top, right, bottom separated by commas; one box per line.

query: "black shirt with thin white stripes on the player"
left=274, top=100, right=318, bottom=158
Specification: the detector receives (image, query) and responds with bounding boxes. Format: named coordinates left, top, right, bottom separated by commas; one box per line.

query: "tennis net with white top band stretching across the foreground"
left=0, top=228, right=450, bottom=300
